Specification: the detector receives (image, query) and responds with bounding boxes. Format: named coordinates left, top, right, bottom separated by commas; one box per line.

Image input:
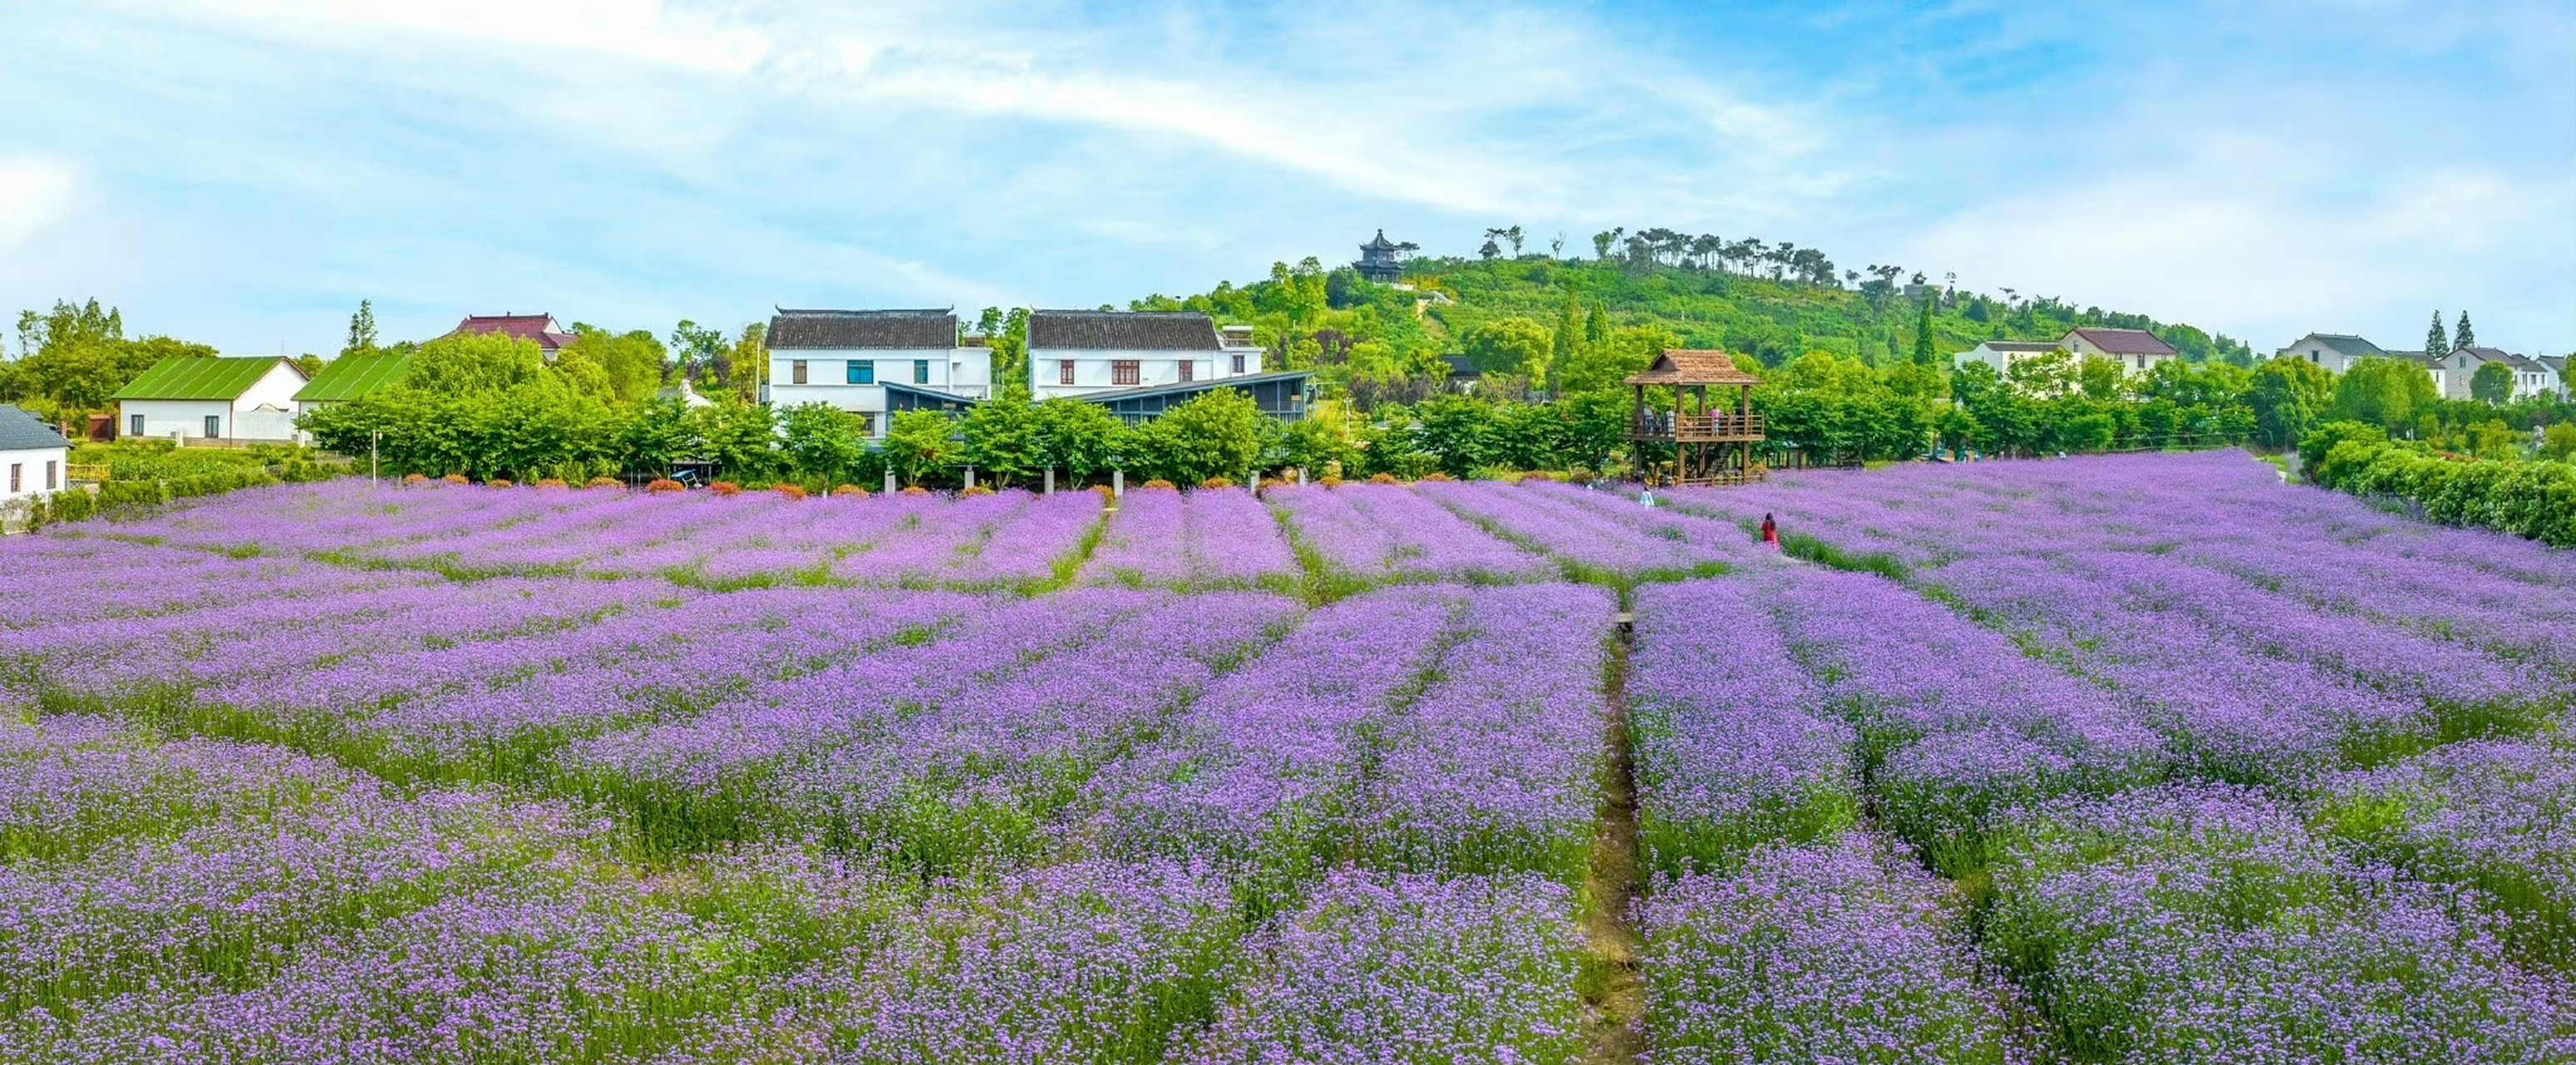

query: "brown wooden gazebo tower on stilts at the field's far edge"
left=1628, top=349, right=1762, bottom=483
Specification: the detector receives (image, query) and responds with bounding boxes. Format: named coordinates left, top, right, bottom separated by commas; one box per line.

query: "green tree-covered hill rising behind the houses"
left=1131, top=240, right=2254, bottom=399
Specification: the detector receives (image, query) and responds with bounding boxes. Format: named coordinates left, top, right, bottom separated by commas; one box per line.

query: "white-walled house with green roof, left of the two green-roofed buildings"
left=108, top=355, right=306, bottom=440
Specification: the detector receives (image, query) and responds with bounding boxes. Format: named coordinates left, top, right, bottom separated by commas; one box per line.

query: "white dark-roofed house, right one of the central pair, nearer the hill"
left=1028, top=311, right=1263, bottom=399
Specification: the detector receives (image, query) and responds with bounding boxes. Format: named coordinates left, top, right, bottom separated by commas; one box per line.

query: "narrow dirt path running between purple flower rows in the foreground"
left=1584, top=615, right=1646, bottom=1065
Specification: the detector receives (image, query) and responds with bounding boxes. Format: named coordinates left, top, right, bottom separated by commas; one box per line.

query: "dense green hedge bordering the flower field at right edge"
left=2308, top=438, right=2576, bottom=548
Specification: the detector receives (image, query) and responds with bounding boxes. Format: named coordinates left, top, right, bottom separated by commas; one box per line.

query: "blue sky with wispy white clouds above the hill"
left=0, top=0, right=2576, bottom=353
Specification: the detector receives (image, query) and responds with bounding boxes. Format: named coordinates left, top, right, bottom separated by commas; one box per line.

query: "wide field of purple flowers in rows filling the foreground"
left=0, top=455, right=2576, bottom=1065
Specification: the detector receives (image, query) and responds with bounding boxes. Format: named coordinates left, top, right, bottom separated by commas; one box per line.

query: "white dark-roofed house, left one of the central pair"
left=767, top=309, right=992, bottom=438
